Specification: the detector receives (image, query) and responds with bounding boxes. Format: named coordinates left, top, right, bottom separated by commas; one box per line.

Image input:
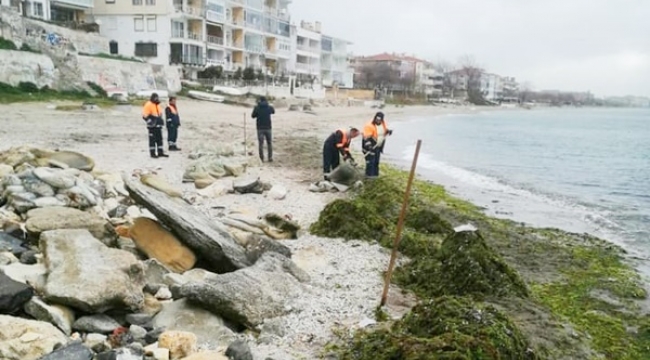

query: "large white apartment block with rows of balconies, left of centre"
left=85, top=0, right=291, bottom=76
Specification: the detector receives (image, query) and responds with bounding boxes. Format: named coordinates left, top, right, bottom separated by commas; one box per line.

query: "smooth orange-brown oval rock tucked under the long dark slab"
left=129, top=217, right=196, bottom=273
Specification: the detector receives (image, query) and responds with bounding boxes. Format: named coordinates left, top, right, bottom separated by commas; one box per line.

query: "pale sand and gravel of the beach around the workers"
left=0, top=99, right=492, bottom=360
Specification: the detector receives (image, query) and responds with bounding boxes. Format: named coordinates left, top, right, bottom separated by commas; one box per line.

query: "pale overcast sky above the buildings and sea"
left=289, top=0, right=650, bottom=96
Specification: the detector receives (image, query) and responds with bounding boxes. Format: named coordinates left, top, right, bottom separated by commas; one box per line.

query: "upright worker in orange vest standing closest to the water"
left=361, top=111, right=393, bottom=179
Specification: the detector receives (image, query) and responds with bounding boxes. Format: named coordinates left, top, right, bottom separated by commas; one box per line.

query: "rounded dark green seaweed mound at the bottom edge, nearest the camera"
left=339, top=296, right=539, bottom=360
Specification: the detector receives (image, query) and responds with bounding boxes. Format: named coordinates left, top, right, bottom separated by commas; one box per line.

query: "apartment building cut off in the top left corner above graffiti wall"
left=0, top=0, right=94, bottom=22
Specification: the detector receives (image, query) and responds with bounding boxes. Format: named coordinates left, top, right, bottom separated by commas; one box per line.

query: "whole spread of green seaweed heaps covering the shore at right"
left=310, top=168, right=650, bottom=360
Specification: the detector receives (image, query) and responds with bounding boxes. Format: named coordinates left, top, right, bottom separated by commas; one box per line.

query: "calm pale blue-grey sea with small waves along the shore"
left=384, top=108, right=650, bottom=276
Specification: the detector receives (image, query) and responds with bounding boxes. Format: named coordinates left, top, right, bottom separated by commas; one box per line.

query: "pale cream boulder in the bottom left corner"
left=0, top=315, right=68, bottom=360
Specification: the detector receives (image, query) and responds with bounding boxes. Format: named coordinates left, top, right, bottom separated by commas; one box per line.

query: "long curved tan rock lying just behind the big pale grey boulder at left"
left=25, top=207, right=116, bottom=245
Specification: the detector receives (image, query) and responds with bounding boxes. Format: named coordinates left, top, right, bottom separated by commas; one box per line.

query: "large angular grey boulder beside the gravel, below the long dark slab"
left=180, top=252, right=309, bottom=328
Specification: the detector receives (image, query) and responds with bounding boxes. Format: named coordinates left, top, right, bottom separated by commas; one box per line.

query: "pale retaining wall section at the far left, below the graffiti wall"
left=0, top=50, right=58, bottom=88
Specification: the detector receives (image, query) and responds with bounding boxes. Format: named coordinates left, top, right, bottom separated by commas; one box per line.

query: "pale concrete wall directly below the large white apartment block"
left=77, top=56, right=181, bottom=93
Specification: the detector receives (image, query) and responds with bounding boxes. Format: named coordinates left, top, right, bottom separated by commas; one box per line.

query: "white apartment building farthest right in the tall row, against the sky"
left=320, top=35, right=354, bottom=89
